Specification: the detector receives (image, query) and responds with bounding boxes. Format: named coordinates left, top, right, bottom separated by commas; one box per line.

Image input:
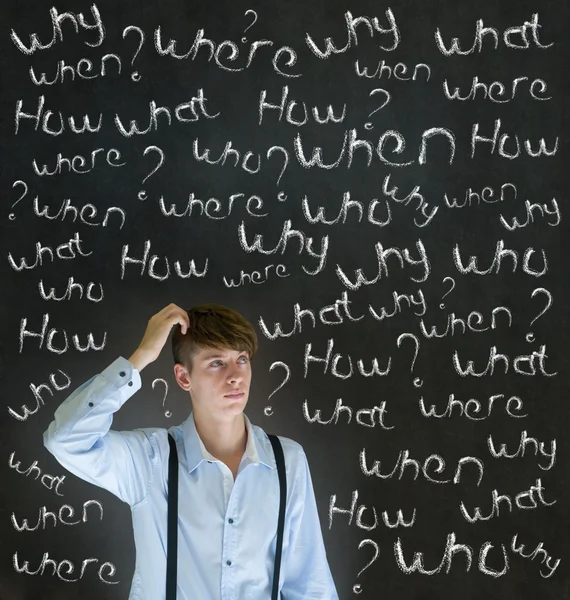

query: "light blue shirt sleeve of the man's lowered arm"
left=281, top=451, right=338, bottom=600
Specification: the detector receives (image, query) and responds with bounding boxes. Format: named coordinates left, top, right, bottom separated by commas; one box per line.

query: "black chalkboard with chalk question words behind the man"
left=0, top=0, right=570, bottom=600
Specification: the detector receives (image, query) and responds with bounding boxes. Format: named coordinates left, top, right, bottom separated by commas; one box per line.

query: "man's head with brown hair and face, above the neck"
left=172, top=304, right=257, bottom=418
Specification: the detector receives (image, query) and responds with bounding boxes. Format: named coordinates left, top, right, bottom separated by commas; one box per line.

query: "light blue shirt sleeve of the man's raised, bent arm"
left=43, top=357, right=159, bottom=506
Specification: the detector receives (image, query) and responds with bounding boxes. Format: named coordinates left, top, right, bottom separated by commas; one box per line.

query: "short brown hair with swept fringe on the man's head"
left=172, top=303, right=257, bottom=373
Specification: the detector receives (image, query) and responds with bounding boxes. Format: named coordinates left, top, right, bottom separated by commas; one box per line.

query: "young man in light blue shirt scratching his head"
left=44, top=304, right=338, bottom=600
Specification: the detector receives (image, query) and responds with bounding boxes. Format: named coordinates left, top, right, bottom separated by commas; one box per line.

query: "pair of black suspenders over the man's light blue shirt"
left=166, top=433, right=287, bottom=600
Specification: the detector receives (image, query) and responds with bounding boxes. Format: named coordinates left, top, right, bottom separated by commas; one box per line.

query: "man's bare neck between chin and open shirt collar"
left=194, top=411, right=247, bottom=461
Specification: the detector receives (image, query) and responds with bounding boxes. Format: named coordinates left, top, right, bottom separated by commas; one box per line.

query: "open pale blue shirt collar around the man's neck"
left=181, top=411, right=276, bottom=473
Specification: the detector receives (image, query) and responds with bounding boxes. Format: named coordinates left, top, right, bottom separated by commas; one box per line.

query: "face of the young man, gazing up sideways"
left=189, top=348, right=251, bottom=419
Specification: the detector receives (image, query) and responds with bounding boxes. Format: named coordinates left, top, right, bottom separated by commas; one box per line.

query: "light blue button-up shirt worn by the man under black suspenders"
left=44, top=357, right=338, bottom=600
